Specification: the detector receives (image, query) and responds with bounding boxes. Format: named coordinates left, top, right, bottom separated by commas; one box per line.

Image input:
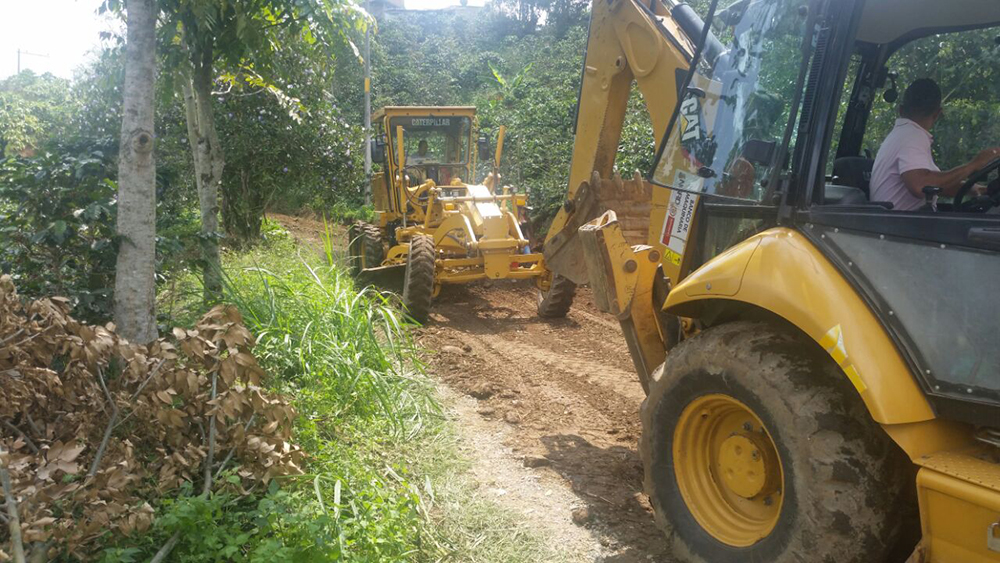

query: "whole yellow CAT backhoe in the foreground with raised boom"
left=541, top=0, right=1000, bottom=563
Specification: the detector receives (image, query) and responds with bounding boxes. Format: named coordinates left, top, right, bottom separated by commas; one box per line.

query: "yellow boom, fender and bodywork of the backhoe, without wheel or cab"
left=545, top=0, right=1000, bottom=563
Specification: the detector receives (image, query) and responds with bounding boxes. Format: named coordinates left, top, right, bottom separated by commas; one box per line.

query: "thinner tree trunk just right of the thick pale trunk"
left=185, top=51, right=226, bottom=302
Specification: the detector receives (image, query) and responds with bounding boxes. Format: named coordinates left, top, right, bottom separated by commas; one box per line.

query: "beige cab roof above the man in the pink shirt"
left=857, top=0, right=1000, bottom=44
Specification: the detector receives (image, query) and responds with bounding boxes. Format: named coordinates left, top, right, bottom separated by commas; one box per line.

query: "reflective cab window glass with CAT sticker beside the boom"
left=653, top=0, right=809, bottom=202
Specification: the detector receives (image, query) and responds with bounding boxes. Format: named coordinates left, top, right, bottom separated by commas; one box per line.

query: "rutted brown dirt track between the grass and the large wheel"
left=276, top=216, right=667, bottom=562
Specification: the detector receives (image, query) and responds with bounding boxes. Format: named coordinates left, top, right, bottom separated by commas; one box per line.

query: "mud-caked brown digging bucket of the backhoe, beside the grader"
left=544, top=172, right=653, bottom=284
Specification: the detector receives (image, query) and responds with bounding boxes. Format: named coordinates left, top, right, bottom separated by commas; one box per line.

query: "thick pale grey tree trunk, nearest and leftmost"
left=114, top=0, right=157, bottom=344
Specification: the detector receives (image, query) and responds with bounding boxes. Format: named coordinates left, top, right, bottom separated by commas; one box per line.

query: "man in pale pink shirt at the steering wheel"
left=871, top=78, right=1000, bottom=211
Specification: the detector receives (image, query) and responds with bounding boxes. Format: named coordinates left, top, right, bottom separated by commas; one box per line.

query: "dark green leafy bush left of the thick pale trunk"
left=0, top=151, right=116, bottom=322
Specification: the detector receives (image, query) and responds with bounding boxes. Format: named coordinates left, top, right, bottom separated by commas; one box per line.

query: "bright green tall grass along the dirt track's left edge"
left=143, top=237, right=438, bottom=561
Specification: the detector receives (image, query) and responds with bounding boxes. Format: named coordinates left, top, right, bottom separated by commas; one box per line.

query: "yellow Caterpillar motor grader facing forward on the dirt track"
left=348, top=106, right=551, bottom=322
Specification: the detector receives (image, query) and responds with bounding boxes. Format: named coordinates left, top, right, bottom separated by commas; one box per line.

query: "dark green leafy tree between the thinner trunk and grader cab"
left=217, top=48, right=364, bottom=242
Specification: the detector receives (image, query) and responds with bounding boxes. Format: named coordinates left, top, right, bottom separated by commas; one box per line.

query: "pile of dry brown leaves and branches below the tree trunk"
left=0, top=276, right=302, bottom=560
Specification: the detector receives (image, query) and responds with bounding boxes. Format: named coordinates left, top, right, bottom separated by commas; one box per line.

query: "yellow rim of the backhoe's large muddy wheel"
left=673, top=394, right=785, bottom=547
